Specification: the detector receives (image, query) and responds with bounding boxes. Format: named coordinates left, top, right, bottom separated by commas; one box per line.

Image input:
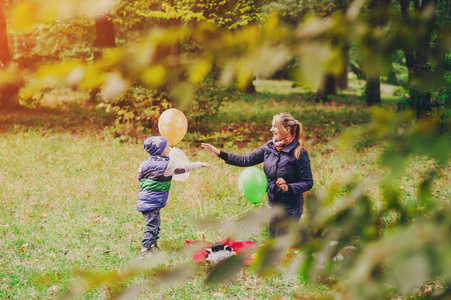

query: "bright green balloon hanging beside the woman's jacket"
left=238, top=167, right=268, bottom=203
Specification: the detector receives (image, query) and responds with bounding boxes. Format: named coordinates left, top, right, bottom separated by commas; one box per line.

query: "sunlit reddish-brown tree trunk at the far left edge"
left=0, top=0, right=20, bottom=108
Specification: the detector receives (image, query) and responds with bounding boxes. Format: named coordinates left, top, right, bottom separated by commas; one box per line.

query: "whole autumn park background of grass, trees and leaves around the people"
left=0, top=0, right=451, bottom=299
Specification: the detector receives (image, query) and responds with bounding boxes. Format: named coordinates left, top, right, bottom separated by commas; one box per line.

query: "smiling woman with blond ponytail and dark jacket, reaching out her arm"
left=202, top=113, right=313, bottom=238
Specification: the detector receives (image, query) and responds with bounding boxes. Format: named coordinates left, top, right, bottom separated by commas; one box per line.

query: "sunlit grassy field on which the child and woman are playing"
left=0, top=82, right=451, bottom=299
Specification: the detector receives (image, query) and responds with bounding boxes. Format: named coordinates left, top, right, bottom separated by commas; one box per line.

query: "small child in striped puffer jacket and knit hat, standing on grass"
left=137, top=136, right=211, bottom=258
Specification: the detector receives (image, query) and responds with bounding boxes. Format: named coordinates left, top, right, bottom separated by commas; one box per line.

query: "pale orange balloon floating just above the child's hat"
left=158, top=108, right=188, bottom=146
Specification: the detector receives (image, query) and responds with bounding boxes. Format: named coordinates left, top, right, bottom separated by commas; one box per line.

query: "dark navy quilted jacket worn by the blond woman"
left=219, top=140, right=313, bottom=209
